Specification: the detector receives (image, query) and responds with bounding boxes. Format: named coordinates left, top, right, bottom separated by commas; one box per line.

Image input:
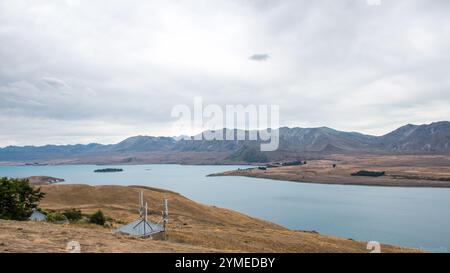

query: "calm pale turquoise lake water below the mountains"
left=0, top=165, right=450, bottom=252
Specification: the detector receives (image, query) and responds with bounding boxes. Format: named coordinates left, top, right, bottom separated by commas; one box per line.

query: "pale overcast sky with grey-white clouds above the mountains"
left=0, top=0, right=450, bottom=146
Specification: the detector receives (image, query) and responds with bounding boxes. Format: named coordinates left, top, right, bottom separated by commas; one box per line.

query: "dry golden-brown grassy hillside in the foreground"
left=0, top=185, right=418, bottom=252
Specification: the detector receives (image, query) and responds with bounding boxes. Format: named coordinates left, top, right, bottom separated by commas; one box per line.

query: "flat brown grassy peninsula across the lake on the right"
left=215, top=155, right=450, bottom=188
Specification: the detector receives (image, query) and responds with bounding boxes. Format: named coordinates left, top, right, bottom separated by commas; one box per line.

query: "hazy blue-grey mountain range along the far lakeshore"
left=0, top=121, right=450, bottom=164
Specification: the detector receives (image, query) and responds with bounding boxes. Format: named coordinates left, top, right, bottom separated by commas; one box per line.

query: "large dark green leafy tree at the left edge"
left=0, top=177, right=45, bottom=220
